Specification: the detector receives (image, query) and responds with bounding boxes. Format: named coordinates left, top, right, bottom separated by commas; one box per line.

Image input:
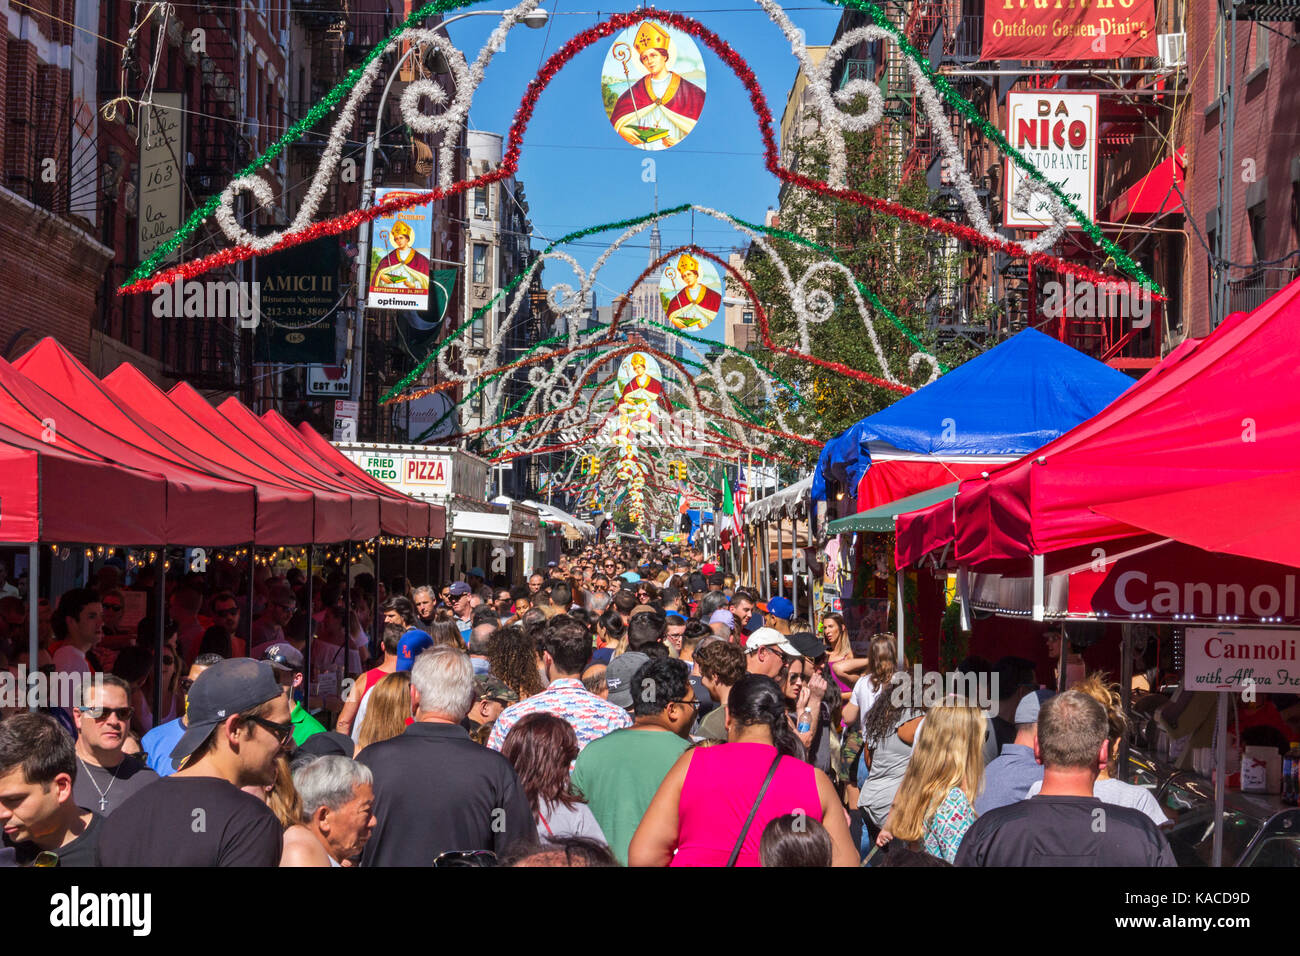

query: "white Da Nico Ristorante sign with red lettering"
left=1002, top=91, right=1099, bottom=229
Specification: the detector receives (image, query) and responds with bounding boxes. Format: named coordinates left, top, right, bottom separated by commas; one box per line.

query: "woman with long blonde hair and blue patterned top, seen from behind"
left=876, top=698, right=988, bottom=864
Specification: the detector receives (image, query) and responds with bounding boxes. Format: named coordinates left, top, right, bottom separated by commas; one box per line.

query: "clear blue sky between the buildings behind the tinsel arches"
left=449, top=0, right=842, bottom=339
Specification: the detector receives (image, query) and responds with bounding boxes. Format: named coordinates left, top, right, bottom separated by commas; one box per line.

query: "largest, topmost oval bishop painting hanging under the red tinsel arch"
left=601, top=20, right=705, bottom=150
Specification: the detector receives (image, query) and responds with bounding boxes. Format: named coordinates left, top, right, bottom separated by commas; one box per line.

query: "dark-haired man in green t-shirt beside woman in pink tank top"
left=572, top=658, right=697, bottom=866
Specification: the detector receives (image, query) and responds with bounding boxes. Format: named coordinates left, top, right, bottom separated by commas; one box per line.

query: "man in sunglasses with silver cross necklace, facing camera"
left=73, top=674, right=159, bottom=817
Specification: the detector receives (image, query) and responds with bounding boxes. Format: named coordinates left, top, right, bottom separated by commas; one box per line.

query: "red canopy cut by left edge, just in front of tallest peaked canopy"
left=0, top=360, right=255, bottom=545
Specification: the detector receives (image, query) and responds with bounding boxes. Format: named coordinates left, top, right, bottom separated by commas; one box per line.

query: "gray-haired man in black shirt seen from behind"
left=360, top=646, right=537, bottom=866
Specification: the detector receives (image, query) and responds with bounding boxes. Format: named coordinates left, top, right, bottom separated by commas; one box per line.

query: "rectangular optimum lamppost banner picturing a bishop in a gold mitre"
left=365, top=189, right=433, bottom=312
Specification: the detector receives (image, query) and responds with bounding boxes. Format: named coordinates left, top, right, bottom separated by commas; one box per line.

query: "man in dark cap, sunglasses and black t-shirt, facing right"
left=99, top=658, right=294, bottom=866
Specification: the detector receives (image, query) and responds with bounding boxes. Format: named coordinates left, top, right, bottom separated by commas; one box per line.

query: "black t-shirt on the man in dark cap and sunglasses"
left=99, top=775, right=283, bottom=866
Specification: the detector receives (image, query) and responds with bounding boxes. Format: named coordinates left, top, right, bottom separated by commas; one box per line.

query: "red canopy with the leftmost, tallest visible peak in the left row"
left=14, top=338, right=312, bottom=544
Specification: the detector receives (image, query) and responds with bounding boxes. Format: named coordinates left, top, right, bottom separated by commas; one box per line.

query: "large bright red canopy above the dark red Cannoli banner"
left=954, top=280, right=1300, bottom=574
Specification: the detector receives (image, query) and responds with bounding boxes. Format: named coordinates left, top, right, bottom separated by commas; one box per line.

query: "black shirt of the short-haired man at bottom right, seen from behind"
left=957, top=795, right=1178, bottom=866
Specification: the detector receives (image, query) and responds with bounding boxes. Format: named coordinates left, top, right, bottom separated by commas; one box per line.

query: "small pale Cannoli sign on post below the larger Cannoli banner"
left=1183, top=627, right=1300, bottom=693
